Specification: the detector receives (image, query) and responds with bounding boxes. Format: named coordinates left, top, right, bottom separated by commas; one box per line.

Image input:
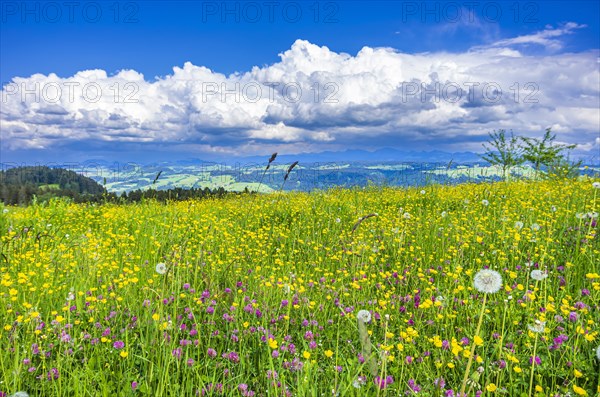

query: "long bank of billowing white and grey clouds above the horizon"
left=0, top=23, right=600, bottom=159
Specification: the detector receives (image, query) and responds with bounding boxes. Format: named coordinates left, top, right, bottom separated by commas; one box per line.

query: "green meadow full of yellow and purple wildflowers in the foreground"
left=0, top=179, right=600, bottom=397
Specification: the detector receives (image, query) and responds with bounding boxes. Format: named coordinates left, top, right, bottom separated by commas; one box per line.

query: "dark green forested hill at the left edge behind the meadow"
left=0, top=166, right=106, bottom=204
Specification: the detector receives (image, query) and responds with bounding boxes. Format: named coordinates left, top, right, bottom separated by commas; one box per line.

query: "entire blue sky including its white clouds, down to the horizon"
left=0, top=1, right=600, bottom=161
